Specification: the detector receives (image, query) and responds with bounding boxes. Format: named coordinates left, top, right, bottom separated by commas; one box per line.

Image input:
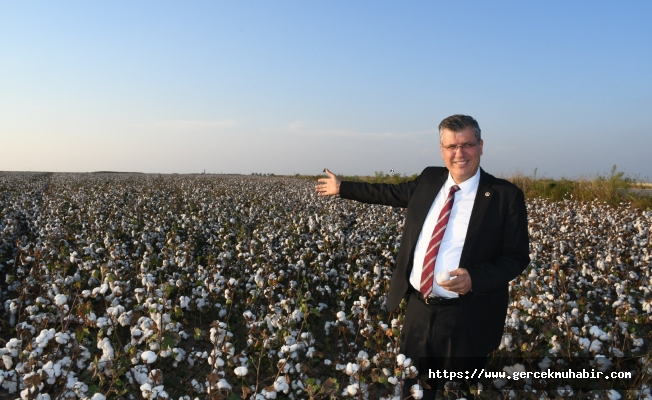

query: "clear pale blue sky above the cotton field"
left=0, top=1, right=652, bottom=180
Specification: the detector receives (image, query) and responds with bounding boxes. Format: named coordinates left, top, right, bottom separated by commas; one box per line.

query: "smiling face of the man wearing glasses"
left=440, top=126, right=482, bottom=184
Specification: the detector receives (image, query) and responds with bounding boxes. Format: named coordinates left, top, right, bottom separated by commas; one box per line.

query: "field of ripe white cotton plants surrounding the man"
left=0, top=173, right=652, bottom=400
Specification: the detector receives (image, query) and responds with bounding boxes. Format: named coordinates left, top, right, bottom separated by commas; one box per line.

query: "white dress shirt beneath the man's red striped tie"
left=410, top=167, right=480, bottom=297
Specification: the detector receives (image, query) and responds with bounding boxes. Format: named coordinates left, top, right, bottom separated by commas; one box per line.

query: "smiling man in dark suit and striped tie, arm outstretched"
left=316, top=115, right=530, bottom=396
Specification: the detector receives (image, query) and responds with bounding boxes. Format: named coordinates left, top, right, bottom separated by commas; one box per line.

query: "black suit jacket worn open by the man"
left=340, top=167, right=530, bottom=354
